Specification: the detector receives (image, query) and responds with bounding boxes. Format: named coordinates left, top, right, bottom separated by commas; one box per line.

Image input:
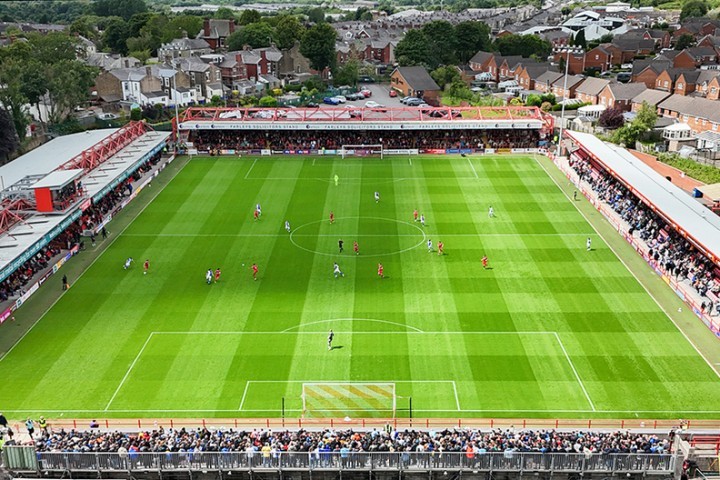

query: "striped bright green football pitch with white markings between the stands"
left=0, top=156, right=720, bottom=418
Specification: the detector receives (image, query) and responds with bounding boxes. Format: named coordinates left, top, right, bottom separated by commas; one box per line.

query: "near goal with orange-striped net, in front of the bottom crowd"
left=302, top=383, right=396, bottom=417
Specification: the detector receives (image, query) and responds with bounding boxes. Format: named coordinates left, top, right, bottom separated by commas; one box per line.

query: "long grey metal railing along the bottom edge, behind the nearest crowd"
left=4, top=447, right=676, bottom=474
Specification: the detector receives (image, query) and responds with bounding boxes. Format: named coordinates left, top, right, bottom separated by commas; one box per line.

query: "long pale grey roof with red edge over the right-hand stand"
left=567, top=131, right=720, bottom=263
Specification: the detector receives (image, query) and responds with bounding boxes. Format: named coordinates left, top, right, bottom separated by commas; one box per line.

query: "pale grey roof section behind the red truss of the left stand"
left=0, top=128, right=118, bottom=193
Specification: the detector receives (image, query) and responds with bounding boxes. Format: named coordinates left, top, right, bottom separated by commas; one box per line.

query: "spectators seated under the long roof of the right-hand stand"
left=570, top=153, right=720, bottom=315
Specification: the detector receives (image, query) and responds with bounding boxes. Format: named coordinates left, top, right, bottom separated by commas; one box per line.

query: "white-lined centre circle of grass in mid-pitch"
left=290, top=217, right=427, bottom=258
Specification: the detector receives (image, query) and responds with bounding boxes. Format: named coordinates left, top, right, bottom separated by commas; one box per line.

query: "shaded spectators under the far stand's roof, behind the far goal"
left=190, top=130, right=540, bottom=153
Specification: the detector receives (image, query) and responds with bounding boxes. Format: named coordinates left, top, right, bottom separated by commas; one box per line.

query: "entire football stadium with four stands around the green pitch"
left=0, top=107, right=720, bottom=478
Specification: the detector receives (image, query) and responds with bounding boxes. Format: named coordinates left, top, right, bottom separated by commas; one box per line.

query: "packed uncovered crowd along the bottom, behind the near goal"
left=25, top=425, right=672, bottom=454
